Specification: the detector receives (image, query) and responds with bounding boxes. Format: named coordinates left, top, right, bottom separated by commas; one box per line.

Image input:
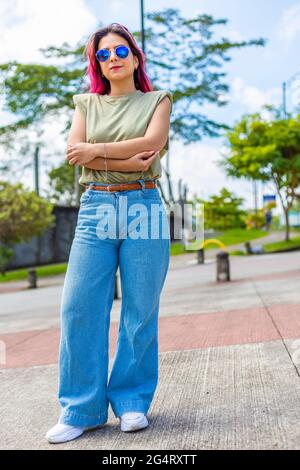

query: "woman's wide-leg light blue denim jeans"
left=58, top=180, right=170, bottom=427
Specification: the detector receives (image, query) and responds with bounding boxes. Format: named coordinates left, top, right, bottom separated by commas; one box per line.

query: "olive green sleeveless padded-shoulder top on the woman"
left=73, top=90, right=173, bottom=186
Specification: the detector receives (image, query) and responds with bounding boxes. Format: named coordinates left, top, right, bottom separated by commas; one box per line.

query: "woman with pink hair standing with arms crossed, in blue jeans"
left=46, top=23, right=173, bottom=443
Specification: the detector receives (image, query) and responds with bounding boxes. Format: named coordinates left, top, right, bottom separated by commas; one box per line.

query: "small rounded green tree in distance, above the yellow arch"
left=201, top=188, right=247, bottom=230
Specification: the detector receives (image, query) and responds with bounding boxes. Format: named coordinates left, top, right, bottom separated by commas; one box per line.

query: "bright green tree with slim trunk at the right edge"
left=219, top=113, right=300, bottom=241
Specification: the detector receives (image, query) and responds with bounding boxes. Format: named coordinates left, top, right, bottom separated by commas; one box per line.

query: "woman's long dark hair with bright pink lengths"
left=84, top=23, right=154, bottom=95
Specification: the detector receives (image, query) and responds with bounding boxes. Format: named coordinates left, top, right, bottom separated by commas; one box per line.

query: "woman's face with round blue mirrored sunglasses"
left=98, top=33, right=139, bottom=82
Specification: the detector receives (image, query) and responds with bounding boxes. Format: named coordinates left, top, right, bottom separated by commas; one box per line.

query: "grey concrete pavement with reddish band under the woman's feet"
left=0, top=248, right=300, bottom=450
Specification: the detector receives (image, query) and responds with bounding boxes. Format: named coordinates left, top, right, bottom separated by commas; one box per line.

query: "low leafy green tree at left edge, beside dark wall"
left=0, top=181, right=55, bottom=273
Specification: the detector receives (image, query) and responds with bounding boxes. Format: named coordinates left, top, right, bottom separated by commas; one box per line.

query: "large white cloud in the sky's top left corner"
left=0, top=0, right=97, bottom=63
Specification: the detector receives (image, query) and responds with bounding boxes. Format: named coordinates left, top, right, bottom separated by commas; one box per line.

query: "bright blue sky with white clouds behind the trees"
left=0, top=0, right=300, bottom=213
